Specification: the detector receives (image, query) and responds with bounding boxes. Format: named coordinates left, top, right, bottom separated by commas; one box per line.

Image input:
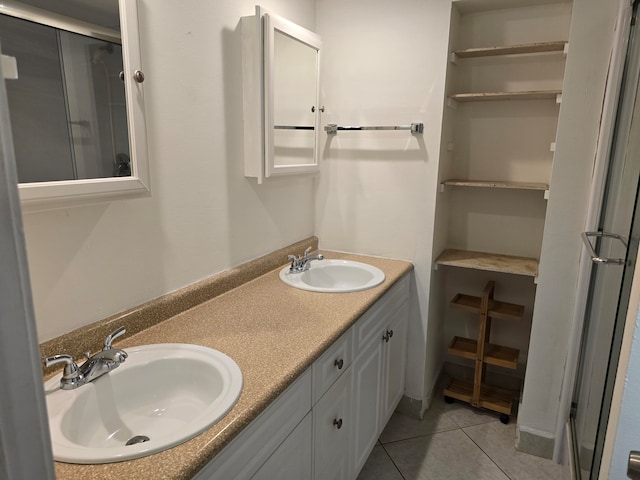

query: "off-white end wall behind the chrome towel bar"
left=316, top=0, right=451, bottom=400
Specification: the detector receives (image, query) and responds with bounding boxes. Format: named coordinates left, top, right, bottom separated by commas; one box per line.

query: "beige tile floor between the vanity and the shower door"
left=358, top=386, right=571, bottom=480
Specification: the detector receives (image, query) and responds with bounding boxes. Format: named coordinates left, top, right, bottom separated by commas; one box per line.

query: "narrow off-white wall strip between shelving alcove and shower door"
left=518, top=0, right=617, bottom=440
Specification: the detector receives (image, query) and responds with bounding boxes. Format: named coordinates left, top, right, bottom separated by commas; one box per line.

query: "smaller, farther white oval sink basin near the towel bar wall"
left=280, top=259, right=384, bottom=293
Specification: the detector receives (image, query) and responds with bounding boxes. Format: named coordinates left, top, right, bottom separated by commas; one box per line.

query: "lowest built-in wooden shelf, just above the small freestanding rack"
left=436, top=248, right=538, bottom=277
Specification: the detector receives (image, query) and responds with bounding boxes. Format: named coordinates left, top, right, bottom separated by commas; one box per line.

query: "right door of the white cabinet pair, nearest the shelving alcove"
left=382, top=303, right=409, bottom=424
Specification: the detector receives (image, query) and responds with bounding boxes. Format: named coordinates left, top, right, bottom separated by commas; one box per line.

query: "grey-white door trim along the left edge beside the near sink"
left=0, top=40, right=55, bottom=480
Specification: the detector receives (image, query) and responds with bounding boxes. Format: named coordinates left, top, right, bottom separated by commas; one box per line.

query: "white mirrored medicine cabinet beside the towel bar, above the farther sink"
left=241, top=6, right=324, bottom=183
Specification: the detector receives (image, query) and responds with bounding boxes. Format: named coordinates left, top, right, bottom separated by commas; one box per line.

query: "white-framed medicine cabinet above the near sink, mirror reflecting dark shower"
left=0, top=0, right=150, bottom=211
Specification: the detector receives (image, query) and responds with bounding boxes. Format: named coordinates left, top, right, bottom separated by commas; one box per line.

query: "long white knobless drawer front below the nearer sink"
left=194, top=370, right=311, bottom=480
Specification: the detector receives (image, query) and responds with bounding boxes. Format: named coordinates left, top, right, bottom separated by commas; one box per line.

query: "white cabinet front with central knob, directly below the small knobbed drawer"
left=314, top=369, right=352, bottom=480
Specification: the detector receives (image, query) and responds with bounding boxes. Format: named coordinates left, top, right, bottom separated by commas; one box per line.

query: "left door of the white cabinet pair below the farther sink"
left=351, top=333, right=382, bottom=478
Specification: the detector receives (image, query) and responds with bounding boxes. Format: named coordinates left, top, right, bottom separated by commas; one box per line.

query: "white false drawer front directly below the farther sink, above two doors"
left=353, top=275, right=409, bottom=352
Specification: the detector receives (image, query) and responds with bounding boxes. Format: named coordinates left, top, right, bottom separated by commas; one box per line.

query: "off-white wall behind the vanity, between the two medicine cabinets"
left=24, top=0, right=315, bottom=341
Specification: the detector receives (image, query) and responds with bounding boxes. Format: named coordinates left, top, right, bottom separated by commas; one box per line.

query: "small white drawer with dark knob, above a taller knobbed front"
left=313, top=329, right=353, bottom=404
